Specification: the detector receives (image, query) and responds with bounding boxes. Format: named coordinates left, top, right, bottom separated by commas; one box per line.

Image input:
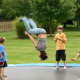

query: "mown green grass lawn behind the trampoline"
left=0, top=28, right=80, bottom=64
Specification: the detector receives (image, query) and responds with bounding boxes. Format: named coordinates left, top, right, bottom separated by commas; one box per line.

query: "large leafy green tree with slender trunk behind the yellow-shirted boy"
left=32, top=0, right=76, bottom=36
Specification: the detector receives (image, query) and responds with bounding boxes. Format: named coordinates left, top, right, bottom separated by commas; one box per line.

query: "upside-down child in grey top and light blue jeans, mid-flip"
left=20, top=16, right=48, bottom=60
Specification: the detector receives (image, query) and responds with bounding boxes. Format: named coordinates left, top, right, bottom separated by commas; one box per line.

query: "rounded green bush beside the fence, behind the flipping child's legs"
left=14, top=17, right=28, bottom=39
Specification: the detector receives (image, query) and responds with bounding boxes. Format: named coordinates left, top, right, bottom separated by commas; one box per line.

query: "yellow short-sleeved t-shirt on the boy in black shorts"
left=54, top=33, right=67, bottom=50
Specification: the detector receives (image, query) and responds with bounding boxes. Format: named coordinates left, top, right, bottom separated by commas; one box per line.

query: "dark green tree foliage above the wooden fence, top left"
left=1, top=0, right=30, bottom=19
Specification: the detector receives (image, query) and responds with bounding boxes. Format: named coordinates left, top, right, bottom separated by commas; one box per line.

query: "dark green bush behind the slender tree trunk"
left=41, top=20, right=58, bottom=34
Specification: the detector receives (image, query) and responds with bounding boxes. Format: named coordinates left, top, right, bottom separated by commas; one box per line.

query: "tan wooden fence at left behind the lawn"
left=0, top=21, right=14, bottom=32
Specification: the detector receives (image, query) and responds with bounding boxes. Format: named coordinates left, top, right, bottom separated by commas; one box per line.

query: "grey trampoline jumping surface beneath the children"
left=5, top=66, right=80, bottom=80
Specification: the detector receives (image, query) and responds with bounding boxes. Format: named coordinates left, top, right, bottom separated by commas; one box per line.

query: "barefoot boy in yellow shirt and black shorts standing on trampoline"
left=54, top=26, right=66, bottom=69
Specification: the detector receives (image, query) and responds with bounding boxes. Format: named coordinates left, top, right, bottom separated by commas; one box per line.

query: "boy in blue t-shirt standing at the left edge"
left=0, top=37, right=7, bottom=80
